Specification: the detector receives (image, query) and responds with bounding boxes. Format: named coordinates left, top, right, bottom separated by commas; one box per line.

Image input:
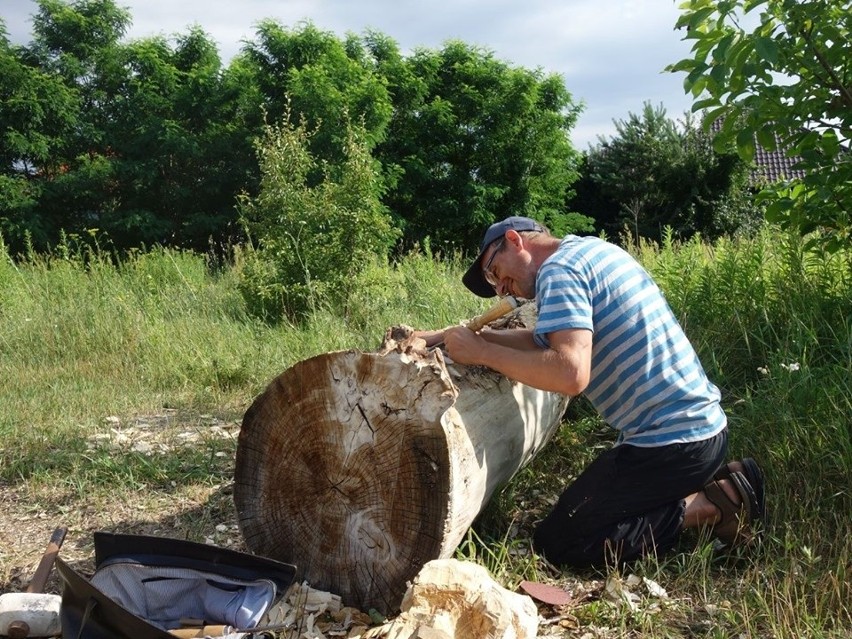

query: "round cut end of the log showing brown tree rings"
left=234, top=352, right=454, bottom=611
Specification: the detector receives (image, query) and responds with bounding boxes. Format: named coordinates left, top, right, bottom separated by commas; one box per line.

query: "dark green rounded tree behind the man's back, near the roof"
left=571, top=103, right=758, bottom=240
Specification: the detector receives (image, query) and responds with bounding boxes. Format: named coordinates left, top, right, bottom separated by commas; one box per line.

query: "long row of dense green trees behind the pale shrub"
left=0, top=0, right=588, bottom=260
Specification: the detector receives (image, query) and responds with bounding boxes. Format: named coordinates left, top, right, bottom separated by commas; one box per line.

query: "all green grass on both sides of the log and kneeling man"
left=0, top=231, right=852, bottom=637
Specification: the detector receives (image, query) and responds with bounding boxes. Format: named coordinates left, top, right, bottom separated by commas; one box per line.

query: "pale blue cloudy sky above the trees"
left=0, top=0, right=691, bottom=150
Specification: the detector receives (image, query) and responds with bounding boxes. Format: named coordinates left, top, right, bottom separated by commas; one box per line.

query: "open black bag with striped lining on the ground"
left=56, top=532, right=296, bottom=639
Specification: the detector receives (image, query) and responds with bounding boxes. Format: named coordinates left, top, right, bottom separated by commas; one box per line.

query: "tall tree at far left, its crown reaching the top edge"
left=12, top=0, right=135, bottom=249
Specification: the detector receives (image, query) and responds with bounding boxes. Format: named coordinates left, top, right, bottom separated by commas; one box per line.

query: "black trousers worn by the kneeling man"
left=533, top=431, right=728, bottom=568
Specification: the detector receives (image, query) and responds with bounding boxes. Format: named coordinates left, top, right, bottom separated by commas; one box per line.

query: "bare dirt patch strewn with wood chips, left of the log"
left=0, top=410, right=245, bottom=593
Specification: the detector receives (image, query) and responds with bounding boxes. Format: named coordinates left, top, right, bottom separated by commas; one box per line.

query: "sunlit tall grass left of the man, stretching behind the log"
left=0, top=238, right=481, bottom=477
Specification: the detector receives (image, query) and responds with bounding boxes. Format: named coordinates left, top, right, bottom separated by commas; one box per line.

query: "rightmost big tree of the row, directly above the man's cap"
left=367, top=39, right=579, bottom=255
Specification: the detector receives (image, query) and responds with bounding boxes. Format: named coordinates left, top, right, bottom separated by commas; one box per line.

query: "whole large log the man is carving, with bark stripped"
left=234, top=318, right=568, bottom=614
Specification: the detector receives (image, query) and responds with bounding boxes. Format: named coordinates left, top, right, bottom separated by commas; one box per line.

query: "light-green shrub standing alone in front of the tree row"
left=240, top=114, right=398, bottom=319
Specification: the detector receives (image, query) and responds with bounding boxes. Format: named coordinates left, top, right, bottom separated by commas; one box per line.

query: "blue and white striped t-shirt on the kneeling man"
left=534, top=235, right=727, bottom=446
